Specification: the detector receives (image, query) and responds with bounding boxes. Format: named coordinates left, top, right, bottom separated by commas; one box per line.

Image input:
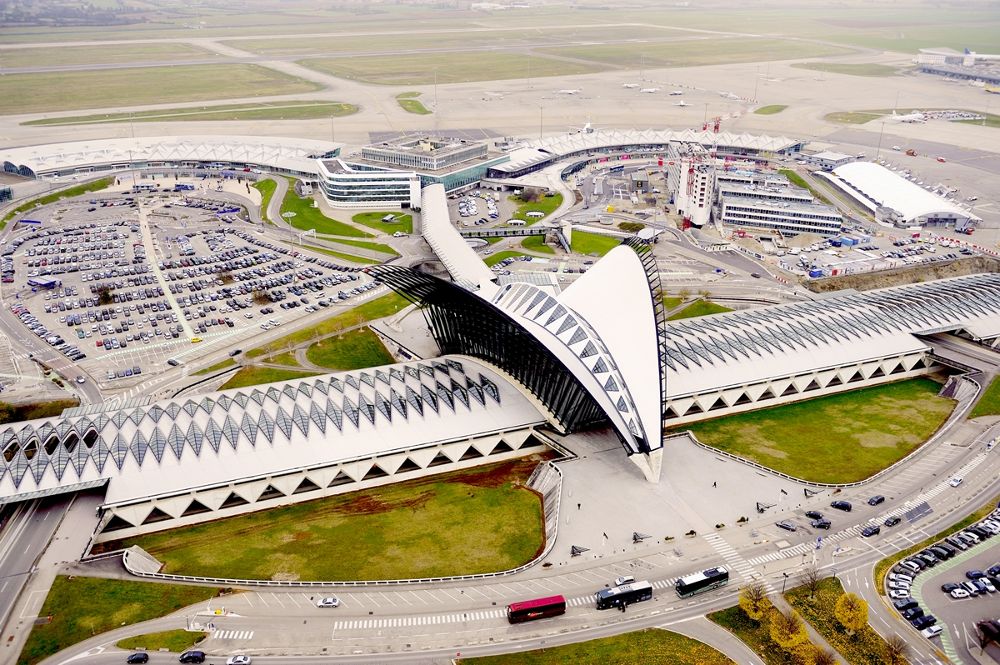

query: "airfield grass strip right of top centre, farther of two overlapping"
left=537, top=37, right=848, bottom=68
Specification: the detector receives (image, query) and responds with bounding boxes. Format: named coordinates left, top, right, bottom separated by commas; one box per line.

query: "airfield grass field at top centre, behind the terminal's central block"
left=299, top=51, right=607, bottom=85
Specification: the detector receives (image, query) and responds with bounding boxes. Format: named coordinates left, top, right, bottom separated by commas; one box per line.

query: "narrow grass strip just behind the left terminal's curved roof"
left=21, top=101, right=358, bottom=126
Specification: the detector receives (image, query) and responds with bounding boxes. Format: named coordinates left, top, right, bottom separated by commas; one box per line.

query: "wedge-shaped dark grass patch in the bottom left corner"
left=17, top=575, right=218, bottom=665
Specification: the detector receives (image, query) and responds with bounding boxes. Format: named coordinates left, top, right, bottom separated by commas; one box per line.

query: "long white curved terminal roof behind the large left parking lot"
left=0, top=136, right=341, bottom=174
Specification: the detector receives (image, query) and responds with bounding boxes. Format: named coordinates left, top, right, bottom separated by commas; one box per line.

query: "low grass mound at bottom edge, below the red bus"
left=456, top=628, right=735, bottom=665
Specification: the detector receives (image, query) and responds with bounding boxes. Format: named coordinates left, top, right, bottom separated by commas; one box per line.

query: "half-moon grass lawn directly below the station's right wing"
left=685, top=378, right=955, bottom=483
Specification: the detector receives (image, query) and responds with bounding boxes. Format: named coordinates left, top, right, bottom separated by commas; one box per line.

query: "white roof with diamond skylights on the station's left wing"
left=0, top=356, right=544, bottom=503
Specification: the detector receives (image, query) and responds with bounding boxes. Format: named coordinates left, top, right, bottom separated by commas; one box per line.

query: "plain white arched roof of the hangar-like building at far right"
left=833, top=162, right=979, bottom=221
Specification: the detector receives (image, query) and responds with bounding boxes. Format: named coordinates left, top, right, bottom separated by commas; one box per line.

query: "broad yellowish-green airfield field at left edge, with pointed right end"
left=0, top=64, right=319, bottom=115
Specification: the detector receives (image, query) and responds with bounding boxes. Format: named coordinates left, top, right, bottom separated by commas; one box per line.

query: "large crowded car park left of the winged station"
left=0, top=191, right=374, bottom=389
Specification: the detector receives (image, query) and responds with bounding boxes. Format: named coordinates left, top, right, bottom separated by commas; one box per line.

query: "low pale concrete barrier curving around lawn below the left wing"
left=119, top=462, right=563, bottom=588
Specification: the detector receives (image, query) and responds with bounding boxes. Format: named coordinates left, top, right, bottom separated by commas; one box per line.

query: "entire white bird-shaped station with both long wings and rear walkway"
left=0, top=184, right=1000, bottom=540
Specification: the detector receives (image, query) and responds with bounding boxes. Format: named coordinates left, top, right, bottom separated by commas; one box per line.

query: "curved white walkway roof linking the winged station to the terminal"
left=420, top=183, right=496, bottom=298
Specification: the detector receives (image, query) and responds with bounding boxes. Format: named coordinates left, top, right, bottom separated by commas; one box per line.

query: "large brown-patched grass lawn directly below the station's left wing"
left=101, top=458, right=545, bottom=580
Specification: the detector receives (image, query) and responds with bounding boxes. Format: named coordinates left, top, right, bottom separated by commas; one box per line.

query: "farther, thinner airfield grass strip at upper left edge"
left=0, top=43, right=208, bottom=68
